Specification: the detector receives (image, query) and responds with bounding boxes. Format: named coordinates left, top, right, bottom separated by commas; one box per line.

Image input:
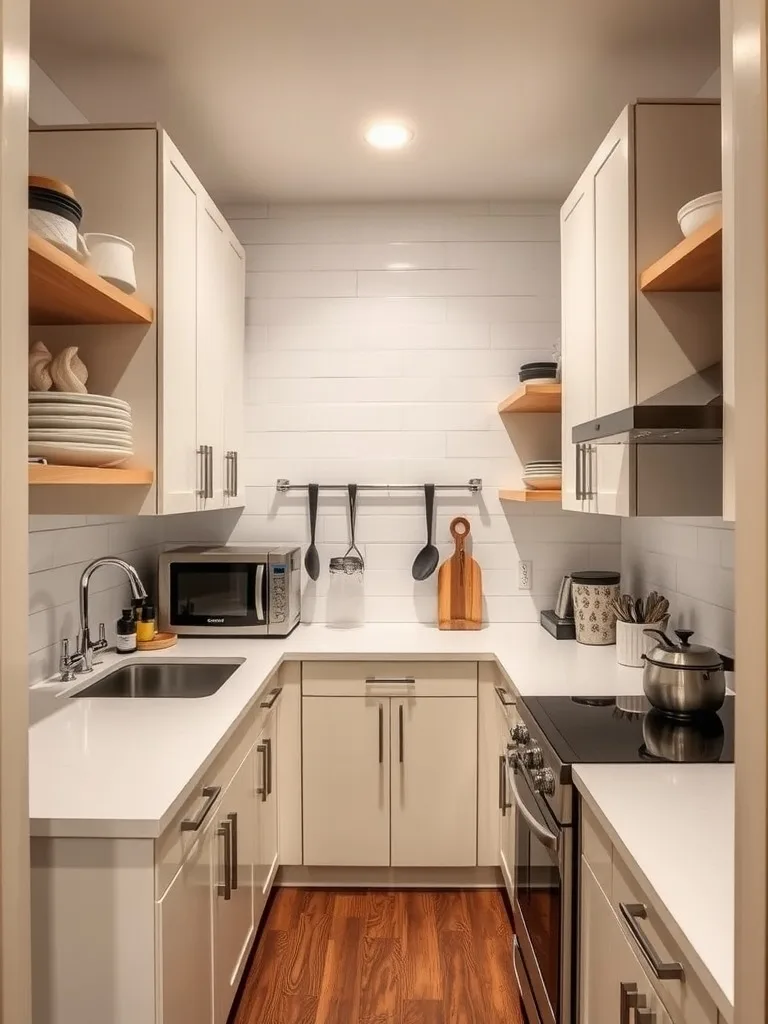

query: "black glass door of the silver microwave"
left=168, top=561, right=268, bottom=636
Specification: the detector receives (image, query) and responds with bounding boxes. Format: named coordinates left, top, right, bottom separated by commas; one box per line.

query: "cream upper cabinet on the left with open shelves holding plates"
left=30, top=125, right=245, bottom=515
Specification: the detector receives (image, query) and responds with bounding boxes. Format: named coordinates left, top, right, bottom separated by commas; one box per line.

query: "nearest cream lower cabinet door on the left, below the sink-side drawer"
left=157, top=823, right=214, bottom=1024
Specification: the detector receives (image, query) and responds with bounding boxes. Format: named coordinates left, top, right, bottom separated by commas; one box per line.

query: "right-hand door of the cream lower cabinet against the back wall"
left=390, top=697, right=477, bottom=867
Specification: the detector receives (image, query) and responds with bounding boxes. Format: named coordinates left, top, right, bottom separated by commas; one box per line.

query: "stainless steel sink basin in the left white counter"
left=70, top=662, right=240, bottom=697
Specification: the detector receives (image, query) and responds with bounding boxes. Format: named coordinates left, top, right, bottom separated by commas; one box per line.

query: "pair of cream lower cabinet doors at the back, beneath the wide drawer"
left=302, top=695, right=477, bottom=867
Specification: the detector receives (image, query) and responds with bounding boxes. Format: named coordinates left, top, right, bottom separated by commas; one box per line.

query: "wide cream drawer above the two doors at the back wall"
left=301, top=662, right=477, bottom=697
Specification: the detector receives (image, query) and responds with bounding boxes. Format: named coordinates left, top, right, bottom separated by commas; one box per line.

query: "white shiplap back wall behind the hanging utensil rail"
left=227, top=203, right=621, bottom=622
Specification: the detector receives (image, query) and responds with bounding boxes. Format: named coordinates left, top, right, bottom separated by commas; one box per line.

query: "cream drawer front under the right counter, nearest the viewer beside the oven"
left=611, top=856, right=718, bottom=1024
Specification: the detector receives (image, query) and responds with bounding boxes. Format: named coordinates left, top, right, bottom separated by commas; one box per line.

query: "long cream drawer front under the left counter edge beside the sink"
left=155, top=700, right=274, bottom=899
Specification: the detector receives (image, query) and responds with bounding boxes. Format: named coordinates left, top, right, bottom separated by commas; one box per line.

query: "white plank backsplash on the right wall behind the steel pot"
left=622, top=518, right=734, bottom=654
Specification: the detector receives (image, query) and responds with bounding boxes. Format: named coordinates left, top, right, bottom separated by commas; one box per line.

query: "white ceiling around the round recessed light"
left=32, top=0, right=719, bottom=202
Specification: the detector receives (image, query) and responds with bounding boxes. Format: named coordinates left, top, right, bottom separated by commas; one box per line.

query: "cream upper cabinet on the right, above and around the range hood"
left=560, top=100, right=722, bottom=516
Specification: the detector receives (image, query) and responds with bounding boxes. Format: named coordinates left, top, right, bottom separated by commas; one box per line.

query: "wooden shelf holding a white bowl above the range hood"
left=640, top=214, right=723, bottom=292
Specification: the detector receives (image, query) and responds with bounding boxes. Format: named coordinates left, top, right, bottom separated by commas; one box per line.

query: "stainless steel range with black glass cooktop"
left=507, top=696, right=734, bottom=1024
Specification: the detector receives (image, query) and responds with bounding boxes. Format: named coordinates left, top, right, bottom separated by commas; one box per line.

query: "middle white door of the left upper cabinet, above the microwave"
left=197, top=204, right=230, bottom=509
